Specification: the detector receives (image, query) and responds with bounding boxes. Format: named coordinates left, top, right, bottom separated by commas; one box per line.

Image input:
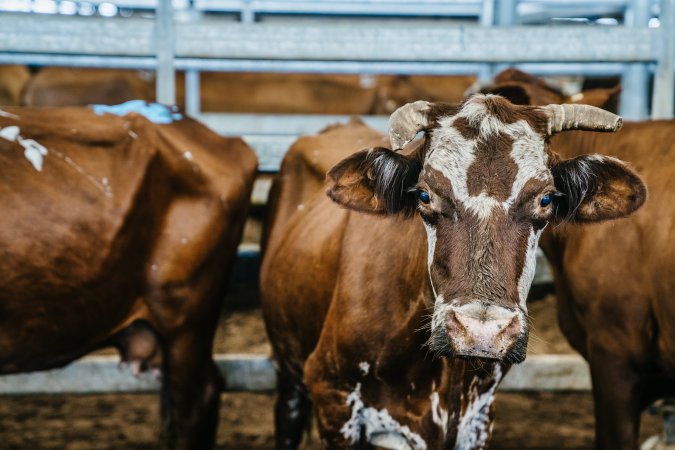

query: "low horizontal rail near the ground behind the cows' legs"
left=0, top=354, right=591, bottom=395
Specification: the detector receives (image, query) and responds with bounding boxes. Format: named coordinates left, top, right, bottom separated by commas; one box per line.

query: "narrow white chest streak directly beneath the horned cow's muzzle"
left=455, top=364, right=502, bottom=450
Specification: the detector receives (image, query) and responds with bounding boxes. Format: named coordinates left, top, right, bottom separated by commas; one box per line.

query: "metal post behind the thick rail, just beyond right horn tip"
left=619, top=0, right=650, bottom=120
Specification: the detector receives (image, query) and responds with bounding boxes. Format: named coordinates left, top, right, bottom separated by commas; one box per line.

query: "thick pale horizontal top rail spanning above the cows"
left=0, top=14, right=659, bottom=63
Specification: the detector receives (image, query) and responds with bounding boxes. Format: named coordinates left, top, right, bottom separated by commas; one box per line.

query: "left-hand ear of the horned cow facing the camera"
left=326, top=147, right=422, bottom=215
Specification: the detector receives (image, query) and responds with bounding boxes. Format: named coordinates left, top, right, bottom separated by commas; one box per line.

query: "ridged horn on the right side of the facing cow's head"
left=542, top=104, right=623, bottom=135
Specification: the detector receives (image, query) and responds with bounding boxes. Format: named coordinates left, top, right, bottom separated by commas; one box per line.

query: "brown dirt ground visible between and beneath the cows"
left=0, top=296, right=660, bottom=450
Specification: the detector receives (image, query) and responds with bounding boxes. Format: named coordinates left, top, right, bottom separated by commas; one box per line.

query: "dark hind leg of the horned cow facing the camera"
left=274, top=369, right=312, bottom=450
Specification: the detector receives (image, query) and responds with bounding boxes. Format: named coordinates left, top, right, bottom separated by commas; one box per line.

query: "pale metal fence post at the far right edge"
left=652, top=0, right=675, bottom=119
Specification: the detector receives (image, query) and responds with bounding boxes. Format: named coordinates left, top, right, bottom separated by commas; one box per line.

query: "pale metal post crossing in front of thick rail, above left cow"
left=155, top=0, right=176, bottom=105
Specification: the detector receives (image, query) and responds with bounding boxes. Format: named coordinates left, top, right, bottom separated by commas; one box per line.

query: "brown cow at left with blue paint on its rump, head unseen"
left=0, top=105, right=257, bottom=449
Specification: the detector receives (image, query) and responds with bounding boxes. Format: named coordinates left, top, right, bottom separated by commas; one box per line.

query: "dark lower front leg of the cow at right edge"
left=590, top=350, right=641, bottom=450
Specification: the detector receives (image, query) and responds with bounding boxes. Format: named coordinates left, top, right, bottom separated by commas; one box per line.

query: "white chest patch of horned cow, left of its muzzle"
left=340, top=383, right=427, bottom=450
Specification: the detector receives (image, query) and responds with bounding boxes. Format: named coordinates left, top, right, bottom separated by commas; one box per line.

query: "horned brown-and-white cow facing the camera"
left=260, top=94, right=646, bottom=450
